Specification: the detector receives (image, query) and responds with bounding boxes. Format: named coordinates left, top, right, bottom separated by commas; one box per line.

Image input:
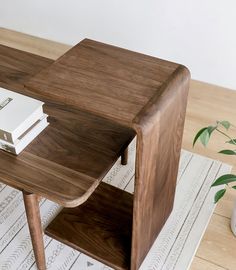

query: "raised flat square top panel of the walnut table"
left=24, top=39, right=178, bottom=125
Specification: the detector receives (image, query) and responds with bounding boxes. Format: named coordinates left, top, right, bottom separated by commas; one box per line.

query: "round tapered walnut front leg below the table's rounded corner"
left=23, top=192, right=46, bottom=270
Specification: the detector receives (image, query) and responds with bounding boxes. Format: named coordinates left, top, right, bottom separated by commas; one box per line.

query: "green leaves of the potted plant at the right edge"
left=193, top=120, right=236, bottom=203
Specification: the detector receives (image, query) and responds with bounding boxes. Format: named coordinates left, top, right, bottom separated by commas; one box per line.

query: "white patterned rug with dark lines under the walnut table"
left=0, top=141, right=231, bottom=270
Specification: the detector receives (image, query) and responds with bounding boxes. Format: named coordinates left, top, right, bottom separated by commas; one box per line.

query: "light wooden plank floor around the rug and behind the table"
left=0, top=28, right=236, bottom=270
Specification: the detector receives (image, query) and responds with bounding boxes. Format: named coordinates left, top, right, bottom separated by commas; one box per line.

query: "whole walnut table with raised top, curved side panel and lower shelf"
left=0, top=39, right=190, bottom=270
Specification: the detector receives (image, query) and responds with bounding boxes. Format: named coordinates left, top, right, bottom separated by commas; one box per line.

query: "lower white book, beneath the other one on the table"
left=0, top=114, right=49, bottom=155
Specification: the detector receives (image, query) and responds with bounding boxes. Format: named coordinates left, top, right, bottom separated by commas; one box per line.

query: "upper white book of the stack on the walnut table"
left=0, top=87, right=44, bottom=144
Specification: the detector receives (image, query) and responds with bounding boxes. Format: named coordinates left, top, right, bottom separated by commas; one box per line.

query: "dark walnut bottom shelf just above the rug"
left=45, top=182, right=133, bottom=269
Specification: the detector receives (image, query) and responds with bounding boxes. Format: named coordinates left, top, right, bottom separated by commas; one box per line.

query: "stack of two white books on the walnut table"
left=0, top=87, right=48, bottom=155
